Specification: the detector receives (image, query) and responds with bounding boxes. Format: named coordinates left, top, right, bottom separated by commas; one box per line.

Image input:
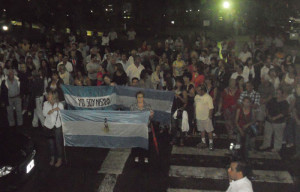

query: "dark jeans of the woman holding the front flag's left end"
left=48, top=127, right=63, bottom=158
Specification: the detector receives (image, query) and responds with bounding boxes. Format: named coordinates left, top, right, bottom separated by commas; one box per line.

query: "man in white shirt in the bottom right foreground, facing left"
left=226, top=161, right=253, bottom=192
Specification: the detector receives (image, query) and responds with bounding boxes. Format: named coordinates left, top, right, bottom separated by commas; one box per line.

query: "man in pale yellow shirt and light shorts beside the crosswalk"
left=194, top=85, right=214, bottom=150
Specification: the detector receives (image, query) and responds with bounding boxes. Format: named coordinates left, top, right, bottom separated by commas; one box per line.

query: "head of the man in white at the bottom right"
left=227, top=161, right=247, bottom=181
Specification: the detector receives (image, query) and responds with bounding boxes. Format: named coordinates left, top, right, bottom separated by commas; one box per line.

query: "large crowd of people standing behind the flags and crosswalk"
left=0, top=29, right=300, bottom=163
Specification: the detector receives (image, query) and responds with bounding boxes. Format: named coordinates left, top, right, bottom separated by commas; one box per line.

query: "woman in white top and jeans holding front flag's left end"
left=43, top=90, right=64, bottom=167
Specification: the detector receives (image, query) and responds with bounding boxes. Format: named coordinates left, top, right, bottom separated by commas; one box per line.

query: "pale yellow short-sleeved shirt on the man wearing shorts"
left=194, top=93, right=214, bottom=120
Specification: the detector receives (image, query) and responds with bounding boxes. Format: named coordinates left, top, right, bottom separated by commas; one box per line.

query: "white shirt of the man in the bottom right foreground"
left=226, top=177, right=253, bottom=192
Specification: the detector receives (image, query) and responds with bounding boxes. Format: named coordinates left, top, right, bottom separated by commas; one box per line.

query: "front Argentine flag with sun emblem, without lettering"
left=61, top=110, right=150, bottom=149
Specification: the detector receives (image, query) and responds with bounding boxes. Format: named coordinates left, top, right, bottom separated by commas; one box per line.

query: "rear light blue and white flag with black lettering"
left=62, top=85, right=174, bottom=124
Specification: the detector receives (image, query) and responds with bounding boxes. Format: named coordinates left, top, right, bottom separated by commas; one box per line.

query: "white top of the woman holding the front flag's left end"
left=43, top=101, right=64, bottom=129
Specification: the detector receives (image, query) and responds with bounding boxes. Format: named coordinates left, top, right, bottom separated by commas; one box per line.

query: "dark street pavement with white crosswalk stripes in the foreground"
left=0, top=107, right=300, bottom=192
